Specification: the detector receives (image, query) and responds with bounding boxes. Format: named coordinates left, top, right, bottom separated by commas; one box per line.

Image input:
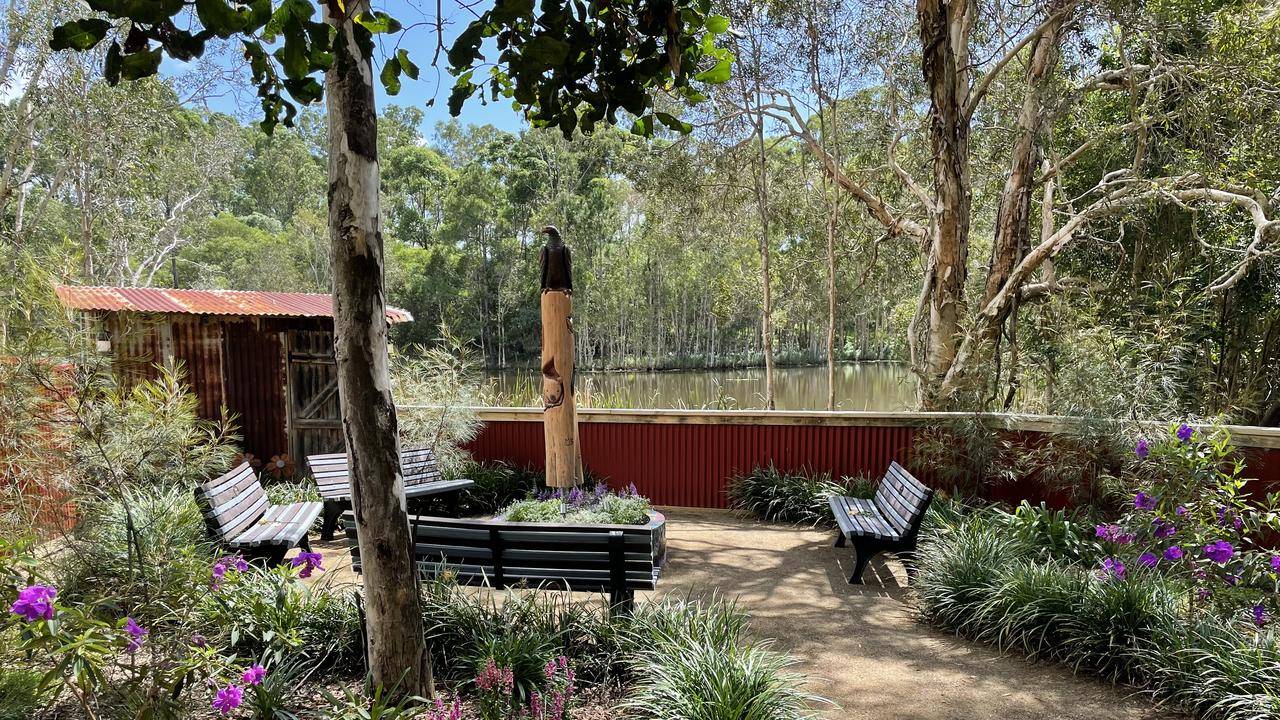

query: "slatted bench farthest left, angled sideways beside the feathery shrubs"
left=196, top=462, right=321, bottom=565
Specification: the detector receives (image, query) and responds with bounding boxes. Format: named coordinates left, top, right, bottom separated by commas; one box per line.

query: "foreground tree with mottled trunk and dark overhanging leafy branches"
left=51, top=0, right=732, bottom=694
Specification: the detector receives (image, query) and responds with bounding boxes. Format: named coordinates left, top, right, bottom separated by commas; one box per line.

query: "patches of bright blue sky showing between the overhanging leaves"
left=186, top=0, right=526, bottom=137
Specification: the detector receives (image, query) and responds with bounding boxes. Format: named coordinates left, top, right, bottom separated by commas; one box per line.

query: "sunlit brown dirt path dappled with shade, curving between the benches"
left=317, top=509, right=1179, bottom=720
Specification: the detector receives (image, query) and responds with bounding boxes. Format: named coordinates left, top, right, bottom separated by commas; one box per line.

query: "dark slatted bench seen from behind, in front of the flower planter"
left=346, top=514, right=667, bottom=612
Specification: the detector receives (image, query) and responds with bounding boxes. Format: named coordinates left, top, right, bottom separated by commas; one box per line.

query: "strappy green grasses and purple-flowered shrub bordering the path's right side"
left=916, top=424, right=1280, bottom=719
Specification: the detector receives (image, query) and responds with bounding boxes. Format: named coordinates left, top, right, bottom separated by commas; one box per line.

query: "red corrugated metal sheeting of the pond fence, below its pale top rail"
left=468, top=412, right=1280, bottom=507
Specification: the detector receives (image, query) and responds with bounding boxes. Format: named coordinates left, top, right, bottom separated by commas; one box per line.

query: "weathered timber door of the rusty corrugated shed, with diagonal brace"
left=288, top=329, right=344, bottom=458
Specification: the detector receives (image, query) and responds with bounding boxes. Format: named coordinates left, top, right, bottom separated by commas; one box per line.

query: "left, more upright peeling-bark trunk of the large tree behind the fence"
left=916, top=0, right=973, bottom=410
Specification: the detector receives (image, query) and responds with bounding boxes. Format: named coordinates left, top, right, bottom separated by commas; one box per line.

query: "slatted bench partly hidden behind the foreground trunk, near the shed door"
left=307, top=447, right=475, bottom=541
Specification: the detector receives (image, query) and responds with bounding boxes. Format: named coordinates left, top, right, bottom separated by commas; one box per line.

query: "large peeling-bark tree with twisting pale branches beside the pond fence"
left=723, top=0, right=1280, bottom=407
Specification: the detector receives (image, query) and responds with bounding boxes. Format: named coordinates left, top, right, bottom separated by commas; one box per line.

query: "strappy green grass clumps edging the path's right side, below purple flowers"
left=915, top=502, right=1280, bottom=720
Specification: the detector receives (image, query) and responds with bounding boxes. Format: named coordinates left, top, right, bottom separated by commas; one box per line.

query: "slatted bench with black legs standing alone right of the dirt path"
left=827, top=462, right=933, bottom=584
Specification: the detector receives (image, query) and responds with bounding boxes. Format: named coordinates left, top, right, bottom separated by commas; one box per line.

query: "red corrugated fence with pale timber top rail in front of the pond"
left=468, top=409, right=1280, bottom=507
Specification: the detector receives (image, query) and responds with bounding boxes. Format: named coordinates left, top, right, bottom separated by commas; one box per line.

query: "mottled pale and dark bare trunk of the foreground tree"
left=325, top=1, right=434, bottom=696
